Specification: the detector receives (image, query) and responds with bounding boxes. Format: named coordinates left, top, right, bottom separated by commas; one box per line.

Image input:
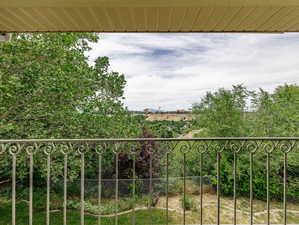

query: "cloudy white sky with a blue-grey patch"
left=89, top=33, right=299, bottom=110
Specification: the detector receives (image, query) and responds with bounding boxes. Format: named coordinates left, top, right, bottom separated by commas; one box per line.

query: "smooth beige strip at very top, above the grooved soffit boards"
left=0, top=0, right=299, bottom=7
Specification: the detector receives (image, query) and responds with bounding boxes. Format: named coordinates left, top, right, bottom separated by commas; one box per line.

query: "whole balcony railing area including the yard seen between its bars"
left=0, top=138, right=299, bottom=225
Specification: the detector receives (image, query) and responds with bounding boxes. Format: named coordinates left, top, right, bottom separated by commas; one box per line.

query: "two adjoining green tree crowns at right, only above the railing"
left=193, top=84, right=299, bottom=137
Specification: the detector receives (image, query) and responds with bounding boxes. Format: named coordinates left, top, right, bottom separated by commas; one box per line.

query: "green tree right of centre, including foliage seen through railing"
left=174, top=85, right=252, bottom=199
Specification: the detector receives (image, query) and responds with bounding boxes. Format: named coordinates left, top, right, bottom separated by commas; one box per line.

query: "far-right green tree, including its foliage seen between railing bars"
left=252, top=84, right=299, bottom=200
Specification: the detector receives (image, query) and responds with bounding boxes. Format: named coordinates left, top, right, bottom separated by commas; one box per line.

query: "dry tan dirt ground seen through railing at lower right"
left=157, top=194, right=299, bottom=224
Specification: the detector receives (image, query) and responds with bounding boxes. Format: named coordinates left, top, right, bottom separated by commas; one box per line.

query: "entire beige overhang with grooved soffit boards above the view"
left=0, top=0, right=299, bottom=32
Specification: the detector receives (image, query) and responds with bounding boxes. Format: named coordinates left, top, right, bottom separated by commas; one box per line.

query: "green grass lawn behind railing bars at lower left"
left=0, top=202, right=166, bottom=225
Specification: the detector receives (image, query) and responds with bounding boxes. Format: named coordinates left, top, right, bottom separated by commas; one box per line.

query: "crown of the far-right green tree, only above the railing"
left=253, top=84, right=299, bottom=137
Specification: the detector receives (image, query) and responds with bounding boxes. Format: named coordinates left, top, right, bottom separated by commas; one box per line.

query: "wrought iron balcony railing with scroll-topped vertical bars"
left=0, top=138, right=299, bottom=225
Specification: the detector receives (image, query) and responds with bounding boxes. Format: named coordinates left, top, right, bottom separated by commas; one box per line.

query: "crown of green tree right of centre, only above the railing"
left=193, top=85, right=251, bottom=137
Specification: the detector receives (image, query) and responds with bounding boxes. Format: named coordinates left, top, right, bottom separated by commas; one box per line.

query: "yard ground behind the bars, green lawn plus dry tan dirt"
left=0, top=193, right=299, bottom=225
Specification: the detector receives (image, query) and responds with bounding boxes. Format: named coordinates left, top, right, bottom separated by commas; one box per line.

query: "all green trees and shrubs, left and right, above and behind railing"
left=0, top=33, right=299, bottom=225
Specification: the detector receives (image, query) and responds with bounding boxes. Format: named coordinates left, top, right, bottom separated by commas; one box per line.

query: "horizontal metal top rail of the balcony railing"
left=0, top=137, right=299, bottom=144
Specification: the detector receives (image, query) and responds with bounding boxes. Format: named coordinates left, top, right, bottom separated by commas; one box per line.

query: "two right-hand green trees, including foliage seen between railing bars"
left=189, top=85, right=299, bottom=201
